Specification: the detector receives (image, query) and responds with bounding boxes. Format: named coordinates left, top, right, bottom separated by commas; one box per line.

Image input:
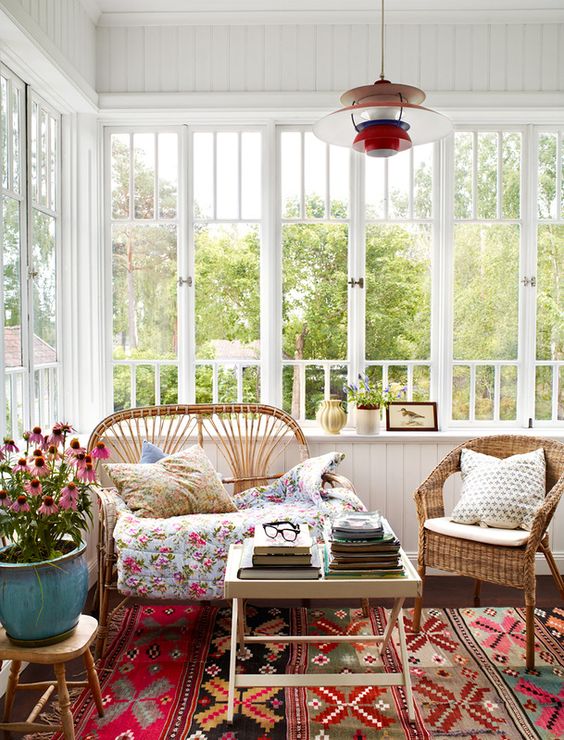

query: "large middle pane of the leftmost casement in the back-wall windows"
left=112, top=224, right=177, bottom=359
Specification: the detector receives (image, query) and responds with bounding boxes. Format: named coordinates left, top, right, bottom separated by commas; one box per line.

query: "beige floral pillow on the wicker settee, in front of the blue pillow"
left=105, top=445, right=237, bottom=519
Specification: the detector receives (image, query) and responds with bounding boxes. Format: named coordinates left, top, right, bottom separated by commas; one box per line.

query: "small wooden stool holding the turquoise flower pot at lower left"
left=0, top=614, right=104, bottom=740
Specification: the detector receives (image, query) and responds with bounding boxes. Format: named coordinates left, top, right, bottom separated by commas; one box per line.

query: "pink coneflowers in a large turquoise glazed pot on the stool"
left=0, top=423, right=109, bottom=646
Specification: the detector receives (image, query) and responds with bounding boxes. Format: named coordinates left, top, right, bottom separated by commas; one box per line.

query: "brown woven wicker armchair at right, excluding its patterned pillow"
left=413, top=435, right=564, bottom=669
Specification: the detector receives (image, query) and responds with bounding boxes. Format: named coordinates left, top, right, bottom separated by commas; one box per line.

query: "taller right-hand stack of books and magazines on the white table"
left=325, top=511, right=405, bottom=578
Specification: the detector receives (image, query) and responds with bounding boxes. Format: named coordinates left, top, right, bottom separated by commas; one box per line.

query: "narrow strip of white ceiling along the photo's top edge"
left=86, top=0, right=564, bottom=25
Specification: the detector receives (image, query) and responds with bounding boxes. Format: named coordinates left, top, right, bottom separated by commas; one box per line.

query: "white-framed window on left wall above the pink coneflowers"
left=0, top=67, right=60, bottom=438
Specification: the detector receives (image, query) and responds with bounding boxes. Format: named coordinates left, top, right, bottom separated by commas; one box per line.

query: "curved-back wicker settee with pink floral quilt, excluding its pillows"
left=88, top=404, right=364, bottom=654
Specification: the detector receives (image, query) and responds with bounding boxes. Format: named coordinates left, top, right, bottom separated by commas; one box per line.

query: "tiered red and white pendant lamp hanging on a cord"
left=313, top=0, right=452, bottom=157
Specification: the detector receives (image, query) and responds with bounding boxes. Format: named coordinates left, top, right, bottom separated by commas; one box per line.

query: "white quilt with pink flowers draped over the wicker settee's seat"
left=114, top=489, right=364, bottom=599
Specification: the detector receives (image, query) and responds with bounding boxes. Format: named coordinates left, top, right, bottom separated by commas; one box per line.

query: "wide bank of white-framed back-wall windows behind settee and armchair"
left=107, top=125, right=564, bottom=426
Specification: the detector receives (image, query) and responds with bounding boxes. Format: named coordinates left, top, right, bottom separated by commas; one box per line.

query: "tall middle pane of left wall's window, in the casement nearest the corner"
left=32, top=210, right=57, bottom=365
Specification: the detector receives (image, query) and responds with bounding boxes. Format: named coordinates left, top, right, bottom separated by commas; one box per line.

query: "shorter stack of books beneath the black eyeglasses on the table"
left=237, top=524, right=321, bottom=580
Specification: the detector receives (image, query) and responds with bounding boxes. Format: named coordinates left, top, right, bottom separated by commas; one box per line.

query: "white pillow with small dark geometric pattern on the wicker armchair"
left=451, top=447, right=546, bottom=530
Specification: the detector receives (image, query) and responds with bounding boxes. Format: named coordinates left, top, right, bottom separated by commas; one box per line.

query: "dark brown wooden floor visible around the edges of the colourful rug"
left=0, top=576, right=562, bottom=740
